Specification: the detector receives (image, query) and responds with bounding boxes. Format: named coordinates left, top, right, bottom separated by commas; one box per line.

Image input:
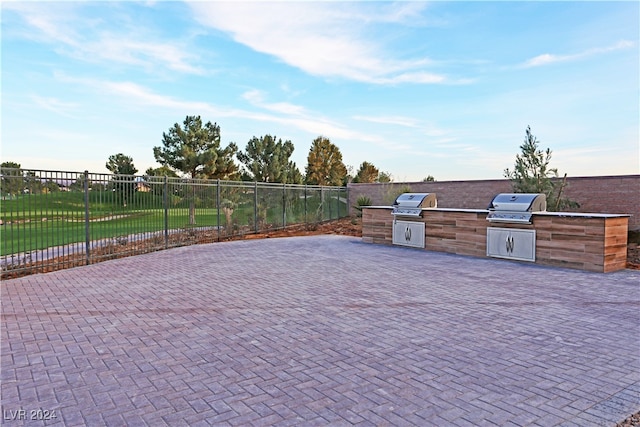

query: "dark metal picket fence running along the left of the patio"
left=0, top=168, right=349, bottom=278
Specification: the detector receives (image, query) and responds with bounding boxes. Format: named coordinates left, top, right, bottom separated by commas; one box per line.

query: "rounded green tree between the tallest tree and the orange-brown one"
left=237, top=135, right=302, bottom=184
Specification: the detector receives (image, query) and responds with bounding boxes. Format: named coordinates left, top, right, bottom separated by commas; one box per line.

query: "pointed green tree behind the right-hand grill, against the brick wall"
left=504, top=126, right=580, bottom=211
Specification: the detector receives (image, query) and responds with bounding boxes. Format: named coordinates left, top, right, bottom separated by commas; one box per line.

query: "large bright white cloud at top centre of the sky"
left=190, top=2, right=459, bottom=84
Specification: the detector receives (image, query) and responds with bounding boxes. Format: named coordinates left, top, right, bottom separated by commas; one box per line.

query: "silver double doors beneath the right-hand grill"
left=487, top=227, right=536, bottom=261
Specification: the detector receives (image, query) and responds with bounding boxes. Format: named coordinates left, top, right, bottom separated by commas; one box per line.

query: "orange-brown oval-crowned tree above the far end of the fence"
left=305, top=136, right=347, bottom=185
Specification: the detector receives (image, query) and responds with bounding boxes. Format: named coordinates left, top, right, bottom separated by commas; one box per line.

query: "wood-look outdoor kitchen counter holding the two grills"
left=362, top=206, right=629, bottom=273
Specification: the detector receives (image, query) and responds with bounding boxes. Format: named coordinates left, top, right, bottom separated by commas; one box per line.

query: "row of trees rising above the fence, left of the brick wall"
left=105, top=116, right=391, bottom=186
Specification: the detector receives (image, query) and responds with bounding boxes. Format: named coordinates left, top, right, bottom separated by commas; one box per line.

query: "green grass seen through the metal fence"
left=0, top=191, right=346, bottom=256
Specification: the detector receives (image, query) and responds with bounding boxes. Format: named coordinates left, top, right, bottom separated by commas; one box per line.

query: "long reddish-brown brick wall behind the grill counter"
left=348, top=175, right=640, bottom=230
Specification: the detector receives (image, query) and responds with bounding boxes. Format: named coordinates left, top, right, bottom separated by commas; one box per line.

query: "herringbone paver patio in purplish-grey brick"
left=0, top=236, right=640, bottom=427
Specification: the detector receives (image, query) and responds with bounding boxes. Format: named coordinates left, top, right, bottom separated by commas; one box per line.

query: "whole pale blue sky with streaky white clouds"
left=1, top=1, right=640, bottom=181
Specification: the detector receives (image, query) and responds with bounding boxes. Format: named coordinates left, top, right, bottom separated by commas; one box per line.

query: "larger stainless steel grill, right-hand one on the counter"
left=487, top=193, right=547, bottom=224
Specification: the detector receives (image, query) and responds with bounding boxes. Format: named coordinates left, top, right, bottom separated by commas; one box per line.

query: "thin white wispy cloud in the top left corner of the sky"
left=2, top=2, right=204, bottom=74
